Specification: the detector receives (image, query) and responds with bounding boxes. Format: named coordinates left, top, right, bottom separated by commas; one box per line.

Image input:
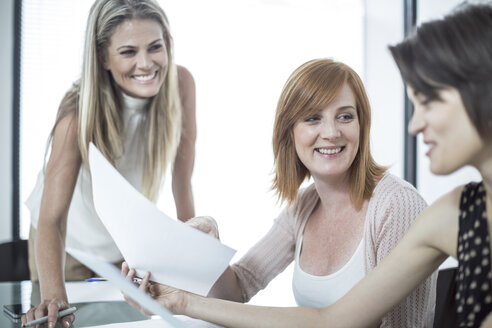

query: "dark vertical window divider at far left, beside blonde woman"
left=12, top=0, right=22, bottom=240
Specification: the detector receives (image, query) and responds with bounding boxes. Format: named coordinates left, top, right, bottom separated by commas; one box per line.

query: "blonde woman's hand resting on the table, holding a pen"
left=21, top=298, right=75, bottom=328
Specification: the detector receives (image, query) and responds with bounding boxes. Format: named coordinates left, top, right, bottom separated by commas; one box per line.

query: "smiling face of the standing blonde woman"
left=103, top=19, right=168, bottom=98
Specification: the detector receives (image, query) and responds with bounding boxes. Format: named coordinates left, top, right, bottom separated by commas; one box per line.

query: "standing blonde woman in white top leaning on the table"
left=23, top=0, right=196, bottom=327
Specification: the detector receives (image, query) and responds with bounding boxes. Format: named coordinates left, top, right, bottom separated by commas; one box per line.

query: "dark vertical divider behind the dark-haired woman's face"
left=403, top=0, right=417, bottom=187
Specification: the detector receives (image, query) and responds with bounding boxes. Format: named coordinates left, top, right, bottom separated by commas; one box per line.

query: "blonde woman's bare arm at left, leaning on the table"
left=28, top=113, right=81, bottom=328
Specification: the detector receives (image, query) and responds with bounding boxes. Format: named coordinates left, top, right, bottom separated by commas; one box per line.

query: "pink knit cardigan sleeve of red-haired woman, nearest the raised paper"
left=232, top=205, right=295, bottom=302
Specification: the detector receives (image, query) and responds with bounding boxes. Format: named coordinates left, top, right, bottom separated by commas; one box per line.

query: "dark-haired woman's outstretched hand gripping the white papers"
left=121, top=262, right=188, bottom=316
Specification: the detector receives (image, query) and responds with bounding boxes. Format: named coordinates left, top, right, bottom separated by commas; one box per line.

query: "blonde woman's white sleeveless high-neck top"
left=26, top=94, right=148, bottom=262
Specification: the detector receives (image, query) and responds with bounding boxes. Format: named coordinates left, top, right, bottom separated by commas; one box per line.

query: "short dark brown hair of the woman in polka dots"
left=389, top=3, right=492, bottom=140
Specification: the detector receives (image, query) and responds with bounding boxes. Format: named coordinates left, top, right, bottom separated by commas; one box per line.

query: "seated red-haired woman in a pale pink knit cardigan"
left=123, top=55, right=436, bottom=327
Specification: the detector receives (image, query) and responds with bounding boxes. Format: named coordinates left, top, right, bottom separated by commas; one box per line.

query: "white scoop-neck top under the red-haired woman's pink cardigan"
left=292, top=234, right=365, bottom=308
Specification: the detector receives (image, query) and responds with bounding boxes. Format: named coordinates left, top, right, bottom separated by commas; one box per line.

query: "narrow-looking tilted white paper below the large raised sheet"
left=67, top=249, right=185, bottom=328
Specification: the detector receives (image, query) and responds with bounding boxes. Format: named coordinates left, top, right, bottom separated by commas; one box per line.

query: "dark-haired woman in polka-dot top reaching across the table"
left=126, top=4, right=492, bottom=328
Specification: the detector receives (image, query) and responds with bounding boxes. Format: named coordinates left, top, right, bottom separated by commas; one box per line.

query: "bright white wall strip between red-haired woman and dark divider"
left=364, top=0, right=405, bottom=177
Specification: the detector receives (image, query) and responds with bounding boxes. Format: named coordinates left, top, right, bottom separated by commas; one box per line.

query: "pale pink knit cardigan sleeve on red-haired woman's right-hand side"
left=365, top=174, right=437, bottom=328
